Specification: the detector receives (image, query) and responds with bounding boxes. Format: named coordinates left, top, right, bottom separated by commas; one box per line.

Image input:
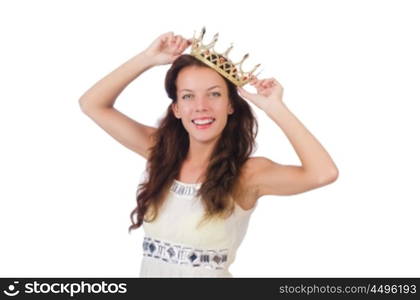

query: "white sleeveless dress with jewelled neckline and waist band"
left=140, top=180, right=256, bottom=277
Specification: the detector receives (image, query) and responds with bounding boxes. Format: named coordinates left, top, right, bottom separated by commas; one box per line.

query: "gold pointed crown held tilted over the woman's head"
left=191, top=27, right=260, bottom=87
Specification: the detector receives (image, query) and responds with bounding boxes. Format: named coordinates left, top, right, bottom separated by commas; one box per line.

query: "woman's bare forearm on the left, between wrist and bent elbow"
left=79, top=52, right=154, bottom=111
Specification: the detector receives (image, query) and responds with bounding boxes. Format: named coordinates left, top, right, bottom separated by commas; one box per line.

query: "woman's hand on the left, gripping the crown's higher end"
left=143, top=31, right=191, bottom=65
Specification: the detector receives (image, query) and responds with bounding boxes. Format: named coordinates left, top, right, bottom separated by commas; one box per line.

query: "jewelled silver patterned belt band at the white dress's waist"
left=143, top=237, right=228, bottom=270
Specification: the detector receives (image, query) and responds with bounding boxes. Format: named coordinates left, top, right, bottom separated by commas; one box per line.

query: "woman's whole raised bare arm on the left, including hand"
left=79, top=32, right=190, bottom=159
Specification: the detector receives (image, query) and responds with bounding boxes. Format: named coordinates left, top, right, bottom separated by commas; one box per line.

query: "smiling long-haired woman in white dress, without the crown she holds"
left=80, top=32, right=338, bottom=277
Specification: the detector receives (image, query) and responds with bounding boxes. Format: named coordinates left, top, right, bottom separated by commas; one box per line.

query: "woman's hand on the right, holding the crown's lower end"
left=238, top=76, right=283, bottom=112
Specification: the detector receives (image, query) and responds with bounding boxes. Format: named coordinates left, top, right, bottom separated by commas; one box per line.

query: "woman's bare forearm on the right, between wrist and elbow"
left=266, top=104, right=338, bottom=181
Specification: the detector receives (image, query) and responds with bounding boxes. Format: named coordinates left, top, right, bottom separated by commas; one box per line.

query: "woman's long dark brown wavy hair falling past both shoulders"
left=129, top=54, right=258, bottom=232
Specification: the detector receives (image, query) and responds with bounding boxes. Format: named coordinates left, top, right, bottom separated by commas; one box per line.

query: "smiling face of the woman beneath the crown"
left=172, top=66, right=233, bottom=142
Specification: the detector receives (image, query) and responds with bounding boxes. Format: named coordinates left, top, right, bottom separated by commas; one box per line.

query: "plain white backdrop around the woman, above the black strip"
left=0, top=0, right=420, bottom=277
